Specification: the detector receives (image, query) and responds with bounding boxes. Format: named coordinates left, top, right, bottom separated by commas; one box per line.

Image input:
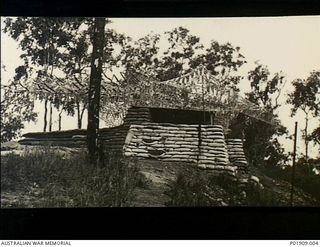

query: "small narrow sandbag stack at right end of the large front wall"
left=226, top=139, right=248, bottom=172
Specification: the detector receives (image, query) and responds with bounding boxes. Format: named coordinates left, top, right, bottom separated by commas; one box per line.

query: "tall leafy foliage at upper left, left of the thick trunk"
left=3, top=17, right=84, bottom=131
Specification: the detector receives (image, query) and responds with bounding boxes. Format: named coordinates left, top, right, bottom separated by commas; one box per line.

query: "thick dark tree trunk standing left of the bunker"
left=87, top=18, right=105, bottom=165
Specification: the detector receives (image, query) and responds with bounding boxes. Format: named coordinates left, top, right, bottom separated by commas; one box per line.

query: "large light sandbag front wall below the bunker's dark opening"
left=124, top=123, right=236, bottom=175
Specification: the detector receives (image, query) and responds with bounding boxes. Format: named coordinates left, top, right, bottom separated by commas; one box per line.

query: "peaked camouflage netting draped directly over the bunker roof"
left=123, top=67, right=274, bottom=124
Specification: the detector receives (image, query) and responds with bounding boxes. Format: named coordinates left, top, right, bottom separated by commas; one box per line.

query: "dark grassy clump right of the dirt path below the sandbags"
left=167, top=170, right=280, bottom=207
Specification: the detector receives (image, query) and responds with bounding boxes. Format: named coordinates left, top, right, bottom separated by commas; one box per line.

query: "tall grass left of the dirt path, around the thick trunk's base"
left=1, top=147, right=141, bottom=208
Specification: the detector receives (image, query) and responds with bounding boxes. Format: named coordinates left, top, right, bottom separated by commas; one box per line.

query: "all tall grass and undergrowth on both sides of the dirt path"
left=1, top=147, right=320, bottom=208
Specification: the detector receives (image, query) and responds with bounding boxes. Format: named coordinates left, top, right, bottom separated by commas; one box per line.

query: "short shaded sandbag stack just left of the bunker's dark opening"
left=123, top=107, right=151, bottom=127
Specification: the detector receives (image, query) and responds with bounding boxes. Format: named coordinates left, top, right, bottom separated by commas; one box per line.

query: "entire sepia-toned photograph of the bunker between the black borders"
left=1, top=15, right=320, bottom=209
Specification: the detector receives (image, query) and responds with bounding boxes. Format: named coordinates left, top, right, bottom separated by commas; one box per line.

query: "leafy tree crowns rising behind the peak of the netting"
left=119, top=27, right=246, bottom=84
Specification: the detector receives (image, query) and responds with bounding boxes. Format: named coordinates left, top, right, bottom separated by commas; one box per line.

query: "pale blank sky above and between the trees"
left=1, top=16, right=320, bottom=156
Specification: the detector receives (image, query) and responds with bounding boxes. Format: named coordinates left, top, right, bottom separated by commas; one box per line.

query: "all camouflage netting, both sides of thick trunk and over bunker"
left=8, top=66, right=277, bottom=124
